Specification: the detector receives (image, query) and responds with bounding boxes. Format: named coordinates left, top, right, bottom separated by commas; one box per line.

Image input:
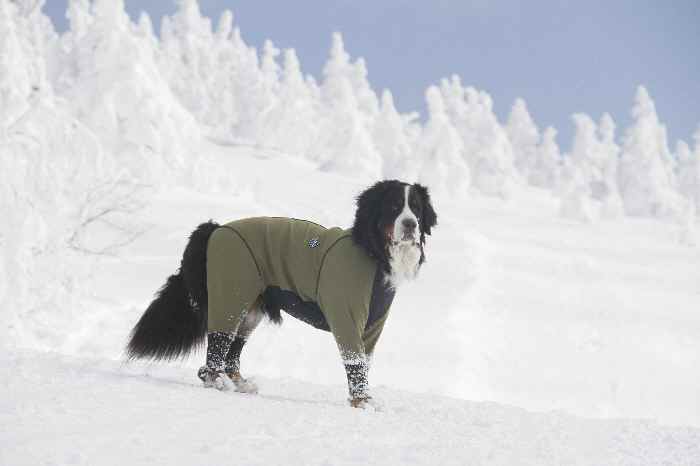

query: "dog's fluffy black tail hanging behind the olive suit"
left=126, top=221, right=219, bottom=360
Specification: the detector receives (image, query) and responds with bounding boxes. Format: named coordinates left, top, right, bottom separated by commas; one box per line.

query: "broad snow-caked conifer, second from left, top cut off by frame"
left=60, top=0, right=199, bottom=184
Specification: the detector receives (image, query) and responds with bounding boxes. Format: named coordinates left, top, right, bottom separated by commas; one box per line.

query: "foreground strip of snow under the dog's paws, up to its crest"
left=0, top=352, right=700, bottom=466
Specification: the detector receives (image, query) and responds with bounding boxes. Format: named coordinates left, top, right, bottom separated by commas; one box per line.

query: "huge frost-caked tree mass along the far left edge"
left=0, top=1, right=144, bottom=350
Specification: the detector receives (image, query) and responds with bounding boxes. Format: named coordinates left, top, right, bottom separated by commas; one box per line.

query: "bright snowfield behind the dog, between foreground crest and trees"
left=4, top=144, right=700, bottom=458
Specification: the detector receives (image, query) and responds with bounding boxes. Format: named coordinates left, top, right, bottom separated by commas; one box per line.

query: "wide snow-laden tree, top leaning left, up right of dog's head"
left=440, top=76, right=518, bottom=197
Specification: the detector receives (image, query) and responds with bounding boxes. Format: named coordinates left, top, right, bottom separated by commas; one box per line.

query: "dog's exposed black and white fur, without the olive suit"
left=127, top=180, right=437, bottom=407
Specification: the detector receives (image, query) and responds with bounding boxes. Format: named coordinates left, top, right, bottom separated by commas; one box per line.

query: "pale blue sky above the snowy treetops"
left=45, top=0, right=700, bottom=149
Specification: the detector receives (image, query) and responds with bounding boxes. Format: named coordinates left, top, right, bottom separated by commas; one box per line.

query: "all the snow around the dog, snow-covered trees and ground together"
left=0, top=0, right=700, bottom=465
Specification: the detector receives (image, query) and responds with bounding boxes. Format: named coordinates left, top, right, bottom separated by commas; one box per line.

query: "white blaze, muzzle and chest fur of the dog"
left=387, top=185, right=420, bottom=288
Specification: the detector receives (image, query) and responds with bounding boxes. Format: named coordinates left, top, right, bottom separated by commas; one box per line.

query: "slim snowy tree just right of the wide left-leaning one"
left=505, top=99, right=540, bottom=180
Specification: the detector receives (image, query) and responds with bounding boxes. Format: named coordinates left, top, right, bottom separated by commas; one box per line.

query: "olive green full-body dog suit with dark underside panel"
left=207, top=217, right=394, bottom=363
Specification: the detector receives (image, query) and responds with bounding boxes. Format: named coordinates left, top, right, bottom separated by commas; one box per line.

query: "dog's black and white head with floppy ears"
left=352, top=180, right=437, bottom=271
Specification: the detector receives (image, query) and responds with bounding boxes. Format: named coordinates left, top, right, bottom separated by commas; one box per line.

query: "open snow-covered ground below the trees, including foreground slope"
left=0, top=143, right=700, bottom=465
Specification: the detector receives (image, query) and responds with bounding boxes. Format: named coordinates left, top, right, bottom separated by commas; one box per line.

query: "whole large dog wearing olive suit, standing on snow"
left=126, top=180, right=437, bottom=407
